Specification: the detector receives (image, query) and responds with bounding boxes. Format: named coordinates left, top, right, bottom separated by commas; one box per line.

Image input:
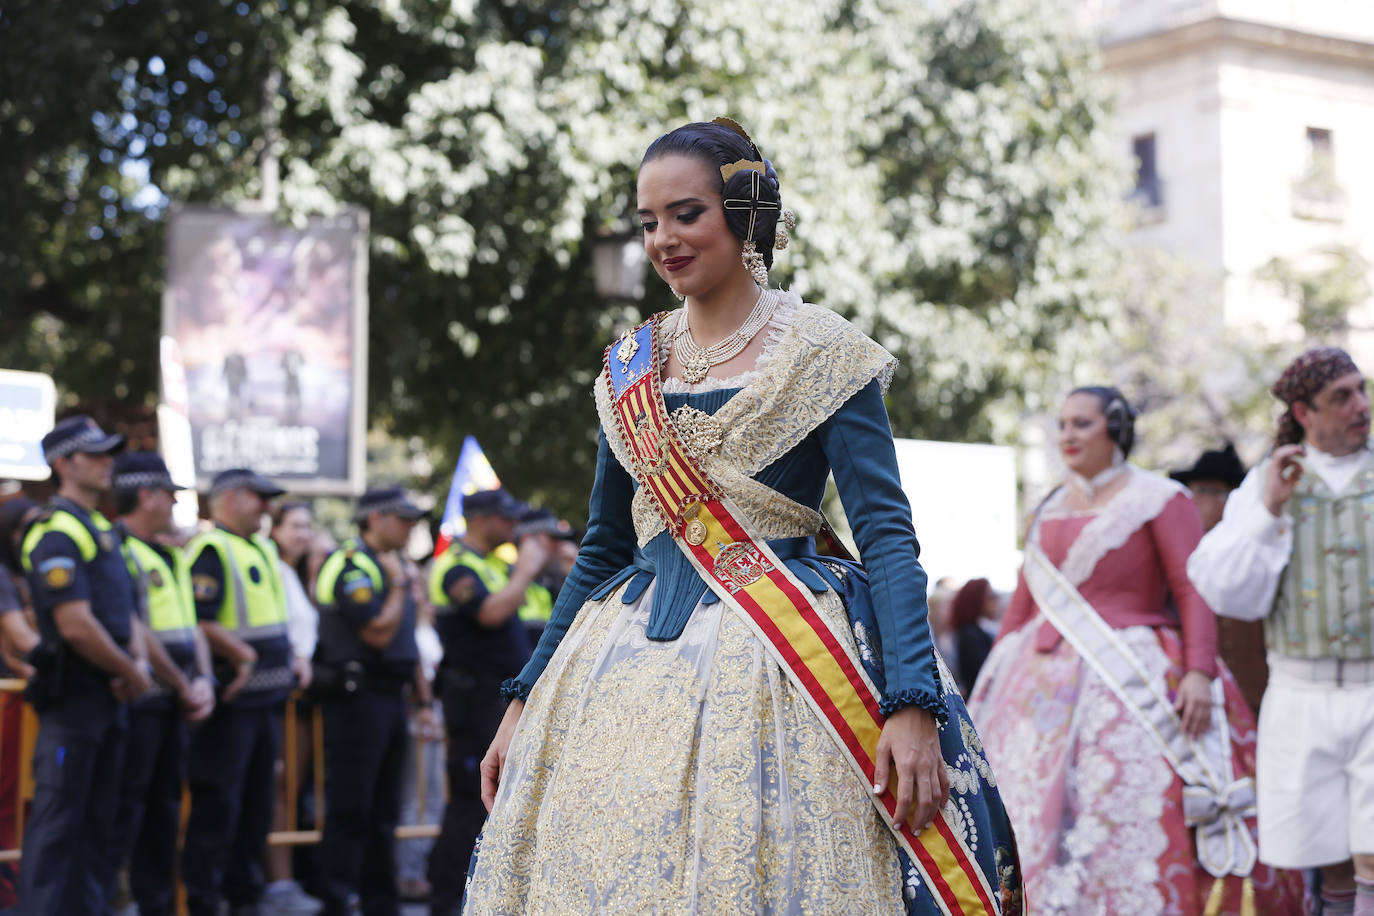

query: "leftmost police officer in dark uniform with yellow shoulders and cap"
left=19, top=416, right=151, bottom=916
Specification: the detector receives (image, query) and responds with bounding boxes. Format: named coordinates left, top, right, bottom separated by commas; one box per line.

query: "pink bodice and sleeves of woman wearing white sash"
left=999, top=493, right=1216, bottom=676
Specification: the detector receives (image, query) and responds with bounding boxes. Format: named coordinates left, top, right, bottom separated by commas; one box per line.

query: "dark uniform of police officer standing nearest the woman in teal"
left=429, top=545, right=530, bottom=916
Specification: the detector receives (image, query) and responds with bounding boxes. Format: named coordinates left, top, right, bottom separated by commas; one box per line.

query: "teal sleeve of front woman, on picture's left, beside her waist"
left=502, top=430, right=636, bottom=699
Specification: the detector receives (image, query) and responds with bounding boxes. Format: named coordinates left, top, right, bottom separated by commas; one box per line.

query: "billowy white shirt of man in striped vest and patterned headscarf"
left=1189, top=445, right=1369, bottom=621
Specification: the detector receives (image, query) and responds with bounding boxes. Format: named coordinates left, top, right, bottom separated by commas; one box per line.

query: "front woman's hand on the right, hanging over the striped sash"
left=872, top=706, right=949, bottom=832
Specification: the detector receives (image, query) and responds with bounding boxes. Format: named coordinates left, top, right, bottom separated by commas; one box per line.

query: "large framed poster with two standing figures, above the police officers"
left=162, top=207, right=367, bottom=494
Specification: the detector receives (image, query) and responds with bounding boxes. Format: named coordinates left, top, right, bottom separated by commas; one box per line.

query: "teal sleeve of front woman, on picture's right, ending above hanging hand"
left=818, top=382, right=947, bottom=721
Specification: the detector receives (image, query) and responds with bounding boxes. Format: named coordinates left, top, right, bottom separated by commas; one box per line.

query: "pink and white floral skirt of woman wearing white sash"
left=969, top=615, right=1303, bottom=916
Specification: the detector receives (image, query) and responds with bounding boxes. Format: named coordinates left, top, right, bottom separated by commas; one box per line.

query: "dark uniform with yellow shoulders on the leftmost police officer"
left=19, top=497, right=136, bottom=916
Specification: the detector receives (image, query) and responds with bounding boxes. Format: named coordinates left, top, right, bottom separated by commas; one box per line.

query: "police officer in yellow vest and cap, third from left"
left=181, top=468, right=295, bottom=916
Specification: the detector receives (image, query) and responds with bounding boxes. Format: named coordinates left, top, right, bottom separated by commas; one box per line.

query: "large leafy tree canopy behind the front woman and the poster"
left=0, top=0, right=1121, bottom=518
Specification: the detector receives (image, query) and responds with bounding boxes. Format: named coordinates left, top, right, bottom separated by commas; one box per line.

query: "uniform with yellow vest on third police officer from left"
left=181, top=516, right=295, bottom=916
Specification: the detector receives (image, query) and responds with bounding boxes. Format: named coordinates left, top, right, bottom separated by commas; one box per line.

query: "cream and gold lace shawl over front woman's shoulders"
left=595, top=293, right=897, bottom=547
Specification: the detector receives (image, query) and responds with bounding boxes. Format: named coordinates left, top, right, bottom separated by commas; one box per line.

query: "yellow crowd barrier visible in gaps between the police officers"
left=0, top=678, right=447, bottom=912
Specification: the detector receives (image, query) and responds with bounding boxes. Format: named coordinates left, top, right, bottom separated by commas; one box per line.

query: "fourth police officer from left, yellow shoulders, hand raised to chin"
left=315, top=486, right=434, bottom=916
